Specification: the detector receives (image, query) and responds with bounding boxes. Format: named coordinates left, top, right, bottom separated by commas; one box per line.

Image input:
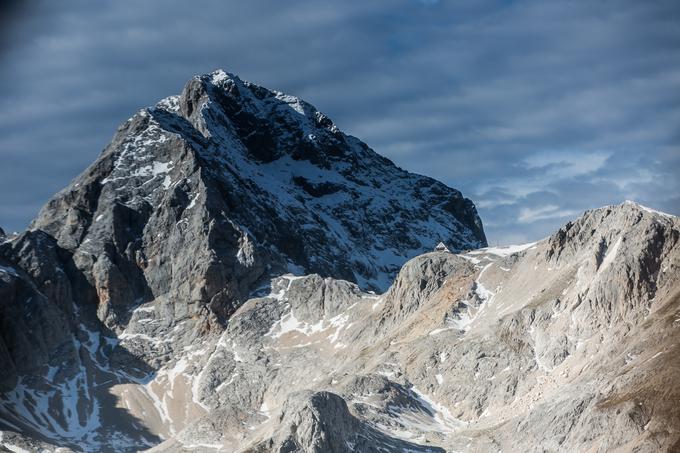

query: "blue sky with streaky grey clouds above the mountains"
left=0, top=0, right=680, bottom=244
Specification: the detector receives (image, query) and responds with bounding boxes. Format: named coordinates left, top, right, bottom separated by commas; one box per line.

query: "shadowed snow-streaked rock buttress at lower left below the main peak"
left=0, top=231, right=160, bottom=451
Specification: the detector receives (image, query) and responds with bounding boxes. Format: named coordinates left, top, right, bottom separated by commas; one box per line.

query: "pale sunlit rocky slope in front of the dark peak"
left=141, top=204, right=680, bottom=452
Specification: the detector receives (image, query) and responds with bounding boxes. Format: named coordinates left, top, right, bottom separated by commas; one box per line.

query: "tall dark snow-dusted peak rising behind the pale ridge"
left=26, top=71, right=485, bottom=329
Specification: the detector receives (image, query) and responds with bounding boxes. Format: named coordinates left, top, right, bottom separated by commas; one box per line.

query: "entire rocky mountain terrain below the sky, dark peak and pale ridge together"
left=0, top=71, right=680, bottom=453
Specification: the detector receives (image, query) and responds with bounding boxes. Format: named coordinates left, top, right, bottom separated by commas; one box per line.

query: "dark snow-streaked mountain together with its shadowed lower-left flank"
left=0, top=71, right=485, bottom=451
